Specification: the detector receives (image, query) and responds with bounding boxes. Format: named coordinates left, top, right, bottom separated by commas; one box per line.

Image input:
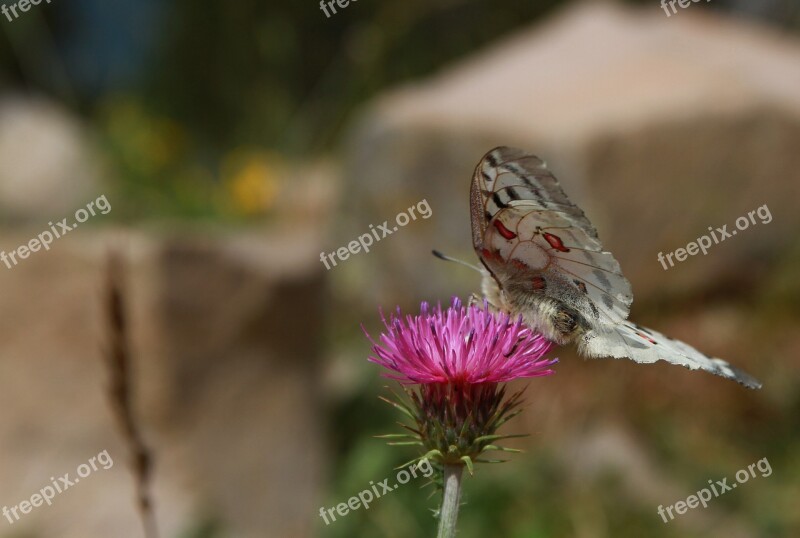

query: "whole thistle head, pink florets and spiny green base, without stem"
left=367, top=299, right=557, bottom=471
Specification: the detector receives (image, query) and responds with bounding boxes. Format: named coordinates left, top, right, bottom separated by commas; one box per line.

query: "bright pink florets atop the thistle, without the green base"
left=365, top=298, right=558, bottom=384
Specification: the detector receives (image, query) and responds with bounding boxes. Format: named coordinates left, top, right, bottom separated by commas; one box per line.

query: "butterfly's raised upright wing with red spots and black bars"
left=470, top=147, right=633, bottom=327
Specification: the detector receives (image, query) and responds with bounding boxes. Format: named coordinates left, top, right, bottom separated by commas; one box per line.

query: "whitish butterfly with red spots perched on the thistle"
left=470, top=147, right=761, bottom=389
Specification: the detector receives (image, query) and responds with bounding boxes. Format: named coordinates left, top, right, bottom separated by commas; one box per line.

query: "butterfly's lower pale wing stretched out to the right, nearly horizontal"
left=578, top=321, right=761, bottom=389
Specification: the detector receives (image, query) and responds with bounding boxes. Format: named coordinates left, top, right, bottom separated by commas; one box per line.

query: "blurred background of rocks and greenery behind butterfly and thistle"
left=0, top=0, right=800, bottom=538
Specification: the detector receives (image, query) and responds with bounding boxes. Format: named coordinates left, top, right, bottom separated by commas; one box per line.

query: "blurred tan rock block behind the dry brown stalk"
left=0, top=228, right=325, bottom=538
